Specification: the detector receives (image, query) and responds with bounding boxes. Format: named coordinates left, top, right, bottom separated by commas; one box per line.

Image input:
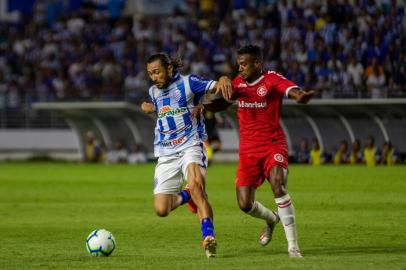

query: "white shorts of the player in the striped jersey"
left=154, top=145, right=207, bottom=194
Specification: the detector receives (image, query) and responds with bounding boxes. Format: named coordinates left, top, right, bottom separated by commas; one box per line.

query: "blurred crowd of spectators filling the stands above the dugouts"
left=0, top=0, right=406, bottom=111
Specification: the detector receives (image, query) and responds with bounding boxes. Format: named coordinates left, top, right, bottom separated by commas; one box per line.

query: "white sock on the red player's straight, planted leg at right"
left=275, top=194, right=299, bottom=249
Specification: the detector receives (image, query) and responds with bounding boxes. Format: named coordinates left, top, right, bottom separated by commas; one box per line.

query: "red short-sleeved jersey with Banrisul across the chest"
left=232, top=71, right=297, bottom=153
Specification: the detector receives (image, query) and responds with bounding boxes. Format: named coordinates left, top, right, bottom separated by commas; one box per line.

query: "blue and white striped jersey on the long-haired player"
left=149, top=74, right=215, bottom=157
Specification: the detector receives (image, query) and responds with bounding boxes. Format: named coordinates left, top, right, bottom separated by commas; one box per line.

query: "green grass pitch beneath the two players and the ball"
left=0, top=163, right=406, bottom=270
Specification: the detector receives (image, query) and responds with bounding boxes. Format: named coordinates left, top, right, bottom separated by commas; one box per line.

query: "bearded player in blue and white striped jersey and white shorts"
left=141, top=53, right=231, bottom=258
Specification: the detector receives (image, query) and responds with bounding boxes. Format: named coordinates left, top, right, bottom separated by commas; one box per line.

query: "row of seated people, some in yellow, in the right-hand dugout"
left=292, top=135, right=403, bottom=166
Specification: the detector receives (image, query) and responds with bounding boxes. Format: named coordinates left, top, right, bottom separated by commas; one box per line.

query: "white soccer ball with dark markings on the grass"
left=86, top=229, right=116, bottom=256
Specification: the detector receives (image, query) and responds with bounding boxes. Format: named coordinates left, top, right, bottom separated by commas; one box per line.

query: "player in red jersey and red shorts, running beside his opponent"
left=205, top=45, right=314, bottom=257
